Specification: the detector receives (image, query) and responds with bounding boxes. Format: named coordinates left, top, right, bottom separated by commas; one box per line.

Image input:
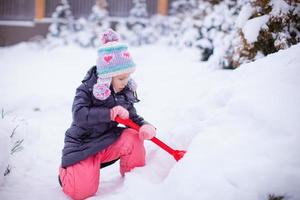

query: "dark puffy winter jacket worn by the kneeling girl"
left=61, top=66, right=146, bottom=167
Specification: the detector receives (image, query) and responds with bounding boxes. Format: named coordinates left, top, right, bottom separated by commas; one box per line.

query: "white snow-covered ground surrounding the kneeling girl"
left=0, top=43, right=300, bottom=200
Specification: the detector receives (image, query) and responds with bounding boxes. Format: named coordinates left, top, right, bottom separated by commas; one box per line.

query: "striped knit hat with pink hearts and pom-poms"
left=93, top=29, right=135, bottom=100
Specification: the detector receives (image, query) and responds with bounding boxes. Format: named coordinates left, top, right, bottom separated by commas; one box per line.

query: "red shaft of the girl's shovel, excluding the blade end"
left=115, top=116, right=177, bottom=160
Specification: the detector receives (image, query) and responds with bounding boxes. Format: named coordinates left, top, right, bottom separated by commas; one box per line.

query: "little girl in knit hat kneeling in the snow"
left=59, top=29, right=156, bottom=199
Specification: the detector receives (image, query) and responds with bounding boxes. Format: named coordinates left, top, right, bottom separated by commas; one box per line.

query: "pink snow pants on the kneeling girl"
left=59, top=128, right=145, bottom=200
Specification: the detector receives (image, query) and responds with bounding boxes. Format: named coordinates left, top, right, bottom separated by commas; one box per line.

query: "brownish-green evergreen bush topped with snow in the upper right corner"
left=228, top=0, right=300, bottom=68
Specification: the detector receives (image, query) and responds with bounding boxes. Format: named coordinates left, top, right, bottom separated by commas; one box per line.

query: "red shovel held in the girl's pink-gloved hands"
left=115, top=116, right=186, bottom=161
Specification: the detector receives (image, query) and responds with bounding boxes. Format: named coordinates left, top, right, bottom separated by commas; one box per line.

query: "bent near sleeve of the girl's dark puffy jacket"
left=72, top=84, right=111, bottom=127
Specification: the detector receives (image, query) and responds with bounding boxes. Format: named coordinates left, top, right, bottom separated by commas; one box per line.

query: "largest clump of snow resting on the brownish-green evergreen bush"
left=242, top=15, right=270, bottom=43
